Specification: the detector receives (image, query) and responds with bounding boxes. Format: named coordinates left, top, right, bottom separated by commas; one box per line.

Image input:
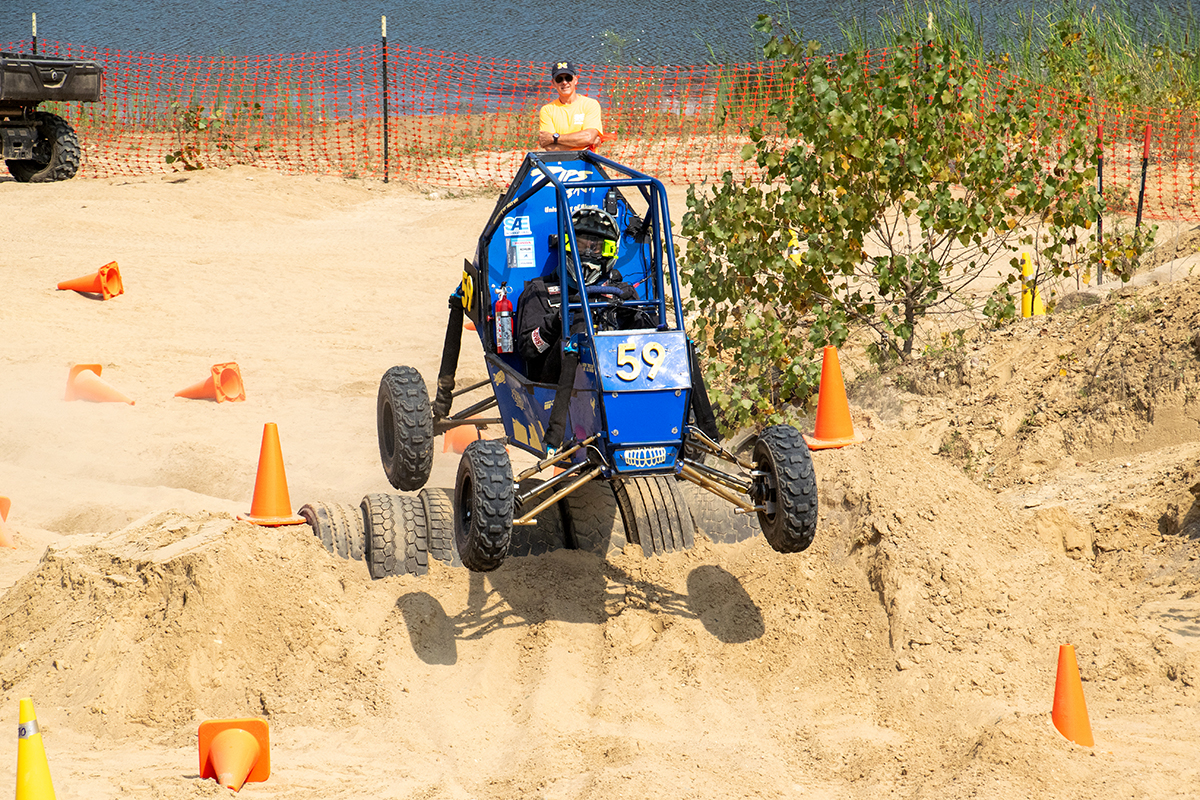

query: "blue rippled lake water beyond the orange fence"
left=0, top=0, right=1184, bottom=64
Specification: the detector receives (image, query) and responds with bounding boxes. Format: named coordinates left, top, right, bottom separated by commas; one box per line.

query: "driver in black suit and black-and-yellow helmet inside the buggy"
left=517, top=206, right=637, bottom=383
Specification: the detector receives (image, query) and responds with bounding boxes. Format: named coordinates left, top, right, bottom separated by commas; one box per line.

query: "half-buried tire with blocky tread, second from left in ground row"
left=361, top=493, right=430, bottom=578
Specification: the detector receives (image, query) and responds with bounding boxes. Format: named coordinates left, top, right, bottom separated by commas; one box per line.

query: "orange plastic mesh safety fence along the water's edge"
left=4, top=41, right=1200, bottom=219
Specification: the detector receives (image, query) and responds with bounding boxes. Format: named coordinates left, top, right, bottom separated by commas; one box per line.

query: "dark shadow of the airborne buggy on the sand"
left=396, top=564, right=766, bottom=664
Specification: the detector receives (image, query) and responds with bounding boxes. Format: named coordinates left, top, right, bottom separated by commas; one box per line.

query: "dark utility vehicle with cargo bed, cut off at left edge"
left=0, top=53, right=104, bottom=184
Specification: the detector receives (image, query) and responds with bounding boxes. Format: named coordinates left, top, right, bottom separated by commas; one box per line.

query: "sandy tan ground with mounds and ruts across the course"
left=0, top=168, right=1200, bottom=800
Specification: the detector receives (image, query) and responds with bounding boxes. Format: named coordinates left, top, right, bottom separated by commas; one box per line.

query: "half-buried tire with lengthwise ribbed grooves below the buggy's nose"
left=613, top=475, right=696, bottom=557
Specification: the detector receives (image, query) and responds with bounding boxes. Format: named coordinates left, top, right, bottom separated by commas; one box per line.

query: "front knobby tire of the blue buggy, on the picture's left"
left=454, top=440, right=512, bottom=572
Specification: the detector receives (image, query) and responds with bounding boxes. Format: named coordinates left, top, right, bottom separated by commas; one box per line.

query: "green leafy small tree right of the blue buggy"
left=683, top=25, right=1137, bottom=427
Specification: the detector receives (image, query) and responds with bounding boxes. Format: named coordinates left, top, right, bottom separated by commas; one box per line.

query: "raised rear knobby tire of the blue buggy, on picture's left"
left=376, top=367, right=433, bottom=492
